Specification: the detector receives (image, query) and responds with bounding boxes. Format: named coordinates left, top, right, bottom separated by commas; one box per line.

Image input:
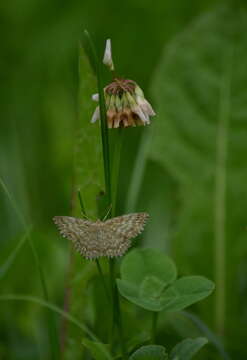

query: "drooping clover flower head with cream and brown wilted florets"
left=91, top=78, right=155, bottom=129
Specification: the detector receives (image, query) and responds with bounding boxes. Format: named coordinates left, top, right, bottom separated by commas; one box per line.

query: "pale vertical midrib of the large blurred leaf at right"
left=214, top=50, right=233, bottom=335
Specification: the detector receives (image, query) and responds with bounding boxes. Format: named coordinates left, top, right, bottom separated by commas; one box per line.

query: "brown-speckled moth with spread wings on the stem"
left=53, top=213, right=149, bottom=259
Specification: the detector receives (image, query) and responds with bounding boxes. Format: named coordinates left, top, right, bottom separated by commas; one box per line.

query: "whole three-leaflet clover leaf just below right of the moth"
left=117, top=249, right=214, bottom=311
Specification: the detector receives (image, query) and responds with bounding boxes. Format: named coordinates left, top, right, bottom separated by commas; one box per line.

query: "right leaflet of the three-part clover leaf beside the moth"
left=162, top=276, right=214, bottom=311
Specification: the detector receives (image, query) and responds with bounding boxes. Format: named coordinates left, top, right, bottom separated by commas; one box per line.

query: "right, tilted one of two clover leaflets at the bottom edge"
left=170, top=337, right=208, bottom=360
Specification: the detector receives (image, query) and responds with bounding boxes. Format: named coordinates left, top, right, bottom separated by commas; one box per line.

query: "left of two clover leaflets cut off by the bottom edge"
left=129, top=345, right=168, bottom=360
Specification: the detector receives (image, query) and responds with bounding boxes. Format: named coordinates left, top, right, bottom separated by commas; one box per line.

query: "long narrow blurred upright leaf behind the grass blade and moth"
left=63, top=47, right=104, bottom=359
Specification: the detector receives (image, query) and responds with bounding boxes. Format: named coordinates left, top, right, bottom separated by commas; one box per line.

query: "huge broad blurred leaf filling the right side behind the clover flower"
left=149, top=7, right=247, bottom=348
